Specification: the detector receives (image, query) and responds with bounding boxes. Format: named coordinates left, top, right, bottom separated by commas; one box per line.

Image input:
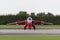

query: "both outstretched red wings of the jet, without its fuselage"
left=8, top=20, right=53, bottom=25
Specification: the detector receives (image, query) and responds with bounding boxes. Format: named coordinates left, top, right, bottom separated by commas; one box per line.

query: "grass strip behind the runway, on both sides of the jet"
left=0, top=25, right=60, bottom=28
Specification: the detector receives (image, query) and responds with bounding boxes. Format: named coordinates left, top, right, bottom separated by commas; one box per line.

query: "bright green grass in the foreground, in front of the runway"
left=0, top=35, right=60, bottom=40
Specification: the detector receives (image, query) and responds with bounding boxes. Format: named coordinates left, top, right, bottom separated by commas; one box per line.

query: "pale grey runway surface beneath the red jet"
left=0, top=29, right=60, bottom=35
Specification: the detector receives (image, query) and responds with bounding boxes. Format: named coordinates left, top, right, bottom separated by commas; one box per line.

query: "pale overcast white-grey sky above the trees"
left=0, top=0, right=60, bottom=15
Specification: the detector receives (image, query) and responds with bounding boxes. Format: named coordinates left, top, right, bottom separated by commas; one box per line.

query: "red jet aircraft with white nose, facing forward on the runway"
left=9, top=17, right=53, bottom=30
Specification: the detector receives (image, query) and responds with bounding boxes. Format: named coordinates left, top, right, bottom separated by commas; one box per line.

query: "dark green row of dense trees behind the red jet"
left=0, top=11, right=60, bottom=24
